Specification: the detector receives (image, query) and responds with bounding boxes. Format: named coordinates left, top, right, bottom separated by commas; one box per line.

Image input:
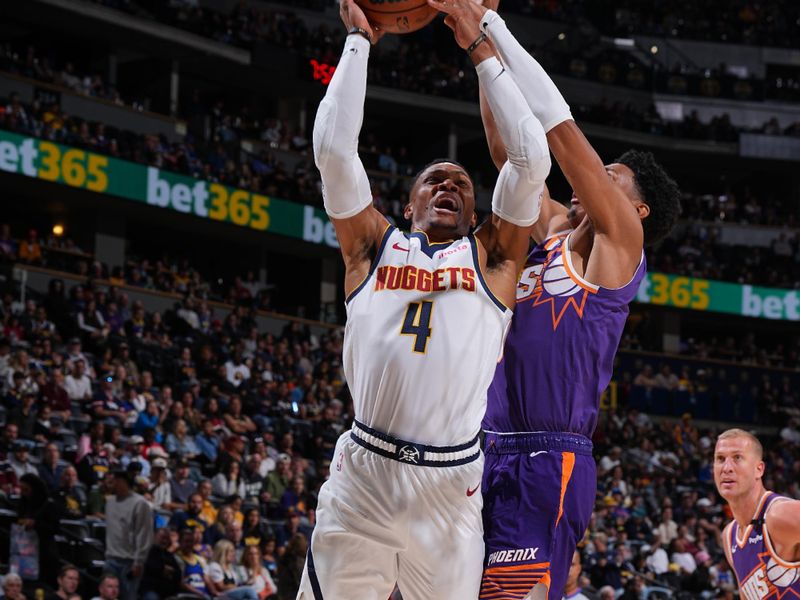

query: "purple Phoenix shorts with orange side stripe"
left=480, top=432, right=597, bottom=600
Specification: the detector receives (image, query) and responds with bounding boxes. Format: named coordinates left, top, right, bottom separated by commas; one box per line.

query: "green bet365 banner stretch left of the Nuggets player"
left=0, top=130, right=339, bottom=248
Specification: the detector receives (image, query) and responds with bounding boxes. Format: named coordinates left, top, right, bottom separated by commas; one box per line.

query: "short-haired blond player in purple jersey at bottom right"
left=714, top=429, right=800, bottom=600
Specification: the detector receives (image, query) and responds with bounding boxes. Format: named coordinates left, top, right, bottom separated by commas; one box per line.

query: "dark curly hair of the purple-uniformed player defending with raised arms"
left=614, top=150, right=681, bottom=246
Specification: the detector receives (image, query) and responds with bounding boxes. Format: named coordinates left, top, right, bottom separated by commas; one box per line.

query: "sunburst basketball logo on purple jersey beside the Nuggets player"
left=517, top=240, right=589, bottom=331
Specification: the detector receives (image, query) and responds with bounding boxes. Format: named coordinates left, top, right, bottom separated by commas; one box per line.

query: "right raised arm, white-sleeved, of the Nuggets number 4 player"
left=428, top=0, right=550, bottom=274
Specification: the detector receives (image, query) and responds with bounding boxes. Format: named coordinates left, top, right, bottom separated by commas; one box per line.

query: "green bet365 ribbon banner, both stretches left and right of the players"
left=0, top=130, right=800, bottom=321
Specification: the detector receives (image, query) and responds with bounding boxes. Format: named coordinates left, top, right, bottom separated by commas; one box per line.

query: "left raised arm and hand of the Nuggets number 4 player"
left=314, top=0, right=387, bottom=290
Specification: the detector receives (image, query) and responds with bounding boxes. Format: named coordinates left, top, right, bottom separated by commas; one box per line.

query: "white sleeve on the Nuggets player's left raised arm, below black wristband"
left=314, top=35, right=372, bottom=219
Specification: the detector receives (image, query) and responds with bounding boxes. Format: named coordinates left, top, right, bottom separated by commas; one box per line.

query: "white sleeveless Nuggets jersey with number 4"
left=343, top=226, right=511, bottom=446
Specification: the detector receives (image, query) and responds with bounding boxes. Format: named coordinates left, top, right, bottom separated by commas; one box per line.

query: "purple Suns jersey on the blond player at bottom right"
left=724, top=492, right=800, bottom=600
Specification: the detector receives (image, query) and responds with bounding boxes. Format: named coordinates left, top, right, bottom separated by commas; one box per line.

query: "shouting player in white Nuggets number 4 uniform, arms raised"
left=298, top=0, right=550, bottom=600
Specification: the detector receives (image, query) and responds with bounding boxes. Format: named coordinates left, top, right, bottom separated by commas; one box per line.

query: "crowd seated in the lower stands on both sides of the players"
left=0, top=258, right=800, bottom=600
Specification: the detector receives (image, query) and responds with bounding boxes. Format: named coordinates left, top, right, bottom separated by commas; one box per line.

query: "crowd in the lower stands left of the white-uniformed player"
left=0, top=260, right=352, bottom=599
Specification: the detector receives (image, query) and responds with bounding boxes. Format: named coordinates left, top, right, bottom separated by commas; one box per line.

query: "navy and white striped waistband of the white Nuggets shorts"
left=350, top=420, right=480, bottom=467
